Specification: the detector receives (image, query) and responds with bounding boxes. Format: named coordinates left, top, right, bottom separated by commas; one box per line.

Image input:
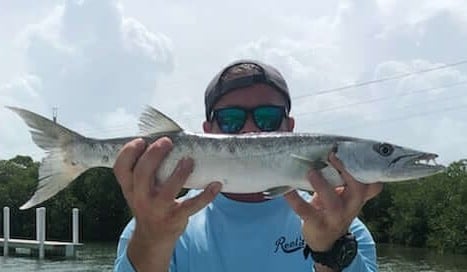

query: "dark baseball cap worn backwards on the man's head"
left=204, top=60, right=291, bottom=120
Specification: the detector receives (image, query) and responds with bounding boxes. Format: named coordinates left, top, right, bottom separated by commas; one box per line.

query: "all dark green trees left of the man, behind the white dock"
left=0, top=156, right=130, bottom=241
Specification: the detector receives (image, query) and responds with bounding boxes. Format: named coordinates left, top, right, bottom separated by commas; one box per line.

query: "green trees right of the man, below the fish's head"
left=362, top=158, right=467, bottom=253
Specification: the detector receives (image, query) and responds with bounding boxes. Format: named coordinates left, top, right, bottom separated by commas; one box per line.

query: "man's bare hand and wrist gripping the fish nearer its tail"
left=114, top=137, right=221, bottom=271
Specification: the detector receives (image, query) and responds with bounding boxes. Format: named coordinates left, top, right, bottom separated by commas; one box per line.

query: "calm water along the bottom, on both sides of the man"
left=0, top=244, right=467, bottom=272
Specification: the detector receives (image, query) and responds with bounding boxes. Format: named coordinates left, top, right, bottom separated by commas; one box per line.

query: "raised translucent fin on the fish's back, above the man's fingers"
left=138, top=106, right=183, bottom=135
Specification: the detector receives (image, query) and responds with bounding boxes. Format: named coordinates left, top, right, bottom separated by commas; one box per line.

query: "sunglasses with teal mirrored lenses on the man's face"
left=211, top=105, right=287, bottom=133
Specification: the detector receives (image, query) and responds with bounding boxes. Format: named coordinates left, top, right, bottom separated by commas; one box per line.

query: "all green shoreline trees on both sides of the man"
left=0, top=155, right=467, bottom=254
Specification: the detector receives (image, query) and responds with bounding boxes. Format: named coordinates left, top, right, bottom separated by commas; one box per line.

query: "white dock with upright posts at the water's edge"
left=0, top=207, right=83, bottom=259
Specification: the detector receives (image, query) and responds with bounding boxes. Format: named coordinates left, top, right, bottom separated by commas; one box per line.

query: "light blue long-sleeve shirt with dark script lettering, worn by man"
left=114, top=191, right=377, bottom=272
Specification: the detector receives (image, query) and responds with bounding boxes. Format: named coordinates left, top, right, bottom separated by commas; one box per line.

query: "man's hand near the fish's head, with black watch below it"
left=285, top=153, right=383, bottom=251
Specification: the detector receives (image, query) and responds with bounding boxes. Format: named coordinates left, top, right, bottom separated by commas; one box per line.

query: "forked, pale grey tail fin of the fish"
left=7, top=107, right=87, bottom=210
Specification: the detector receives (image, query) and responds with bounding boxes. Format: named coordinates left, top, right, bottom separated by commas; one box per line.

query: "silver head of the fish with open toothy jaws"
left=336, top=141, right=445, bottom=183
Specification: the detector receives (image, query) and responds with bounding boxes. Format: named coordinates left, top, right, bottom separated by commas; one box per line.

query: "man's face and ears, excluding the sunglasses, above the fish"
left=203, top=84, right=294, bottom=133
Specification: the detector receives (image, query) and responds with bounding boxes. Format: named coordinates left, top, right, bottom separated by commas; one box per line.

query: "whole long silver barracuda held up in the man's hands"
left=8, top=107, right=445, bottom=209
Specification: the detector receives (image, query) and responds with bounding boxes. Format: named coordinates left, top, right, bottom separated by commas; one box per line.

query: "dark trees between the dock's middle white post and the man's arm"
left=40, top=168, right=130, bottom=241
